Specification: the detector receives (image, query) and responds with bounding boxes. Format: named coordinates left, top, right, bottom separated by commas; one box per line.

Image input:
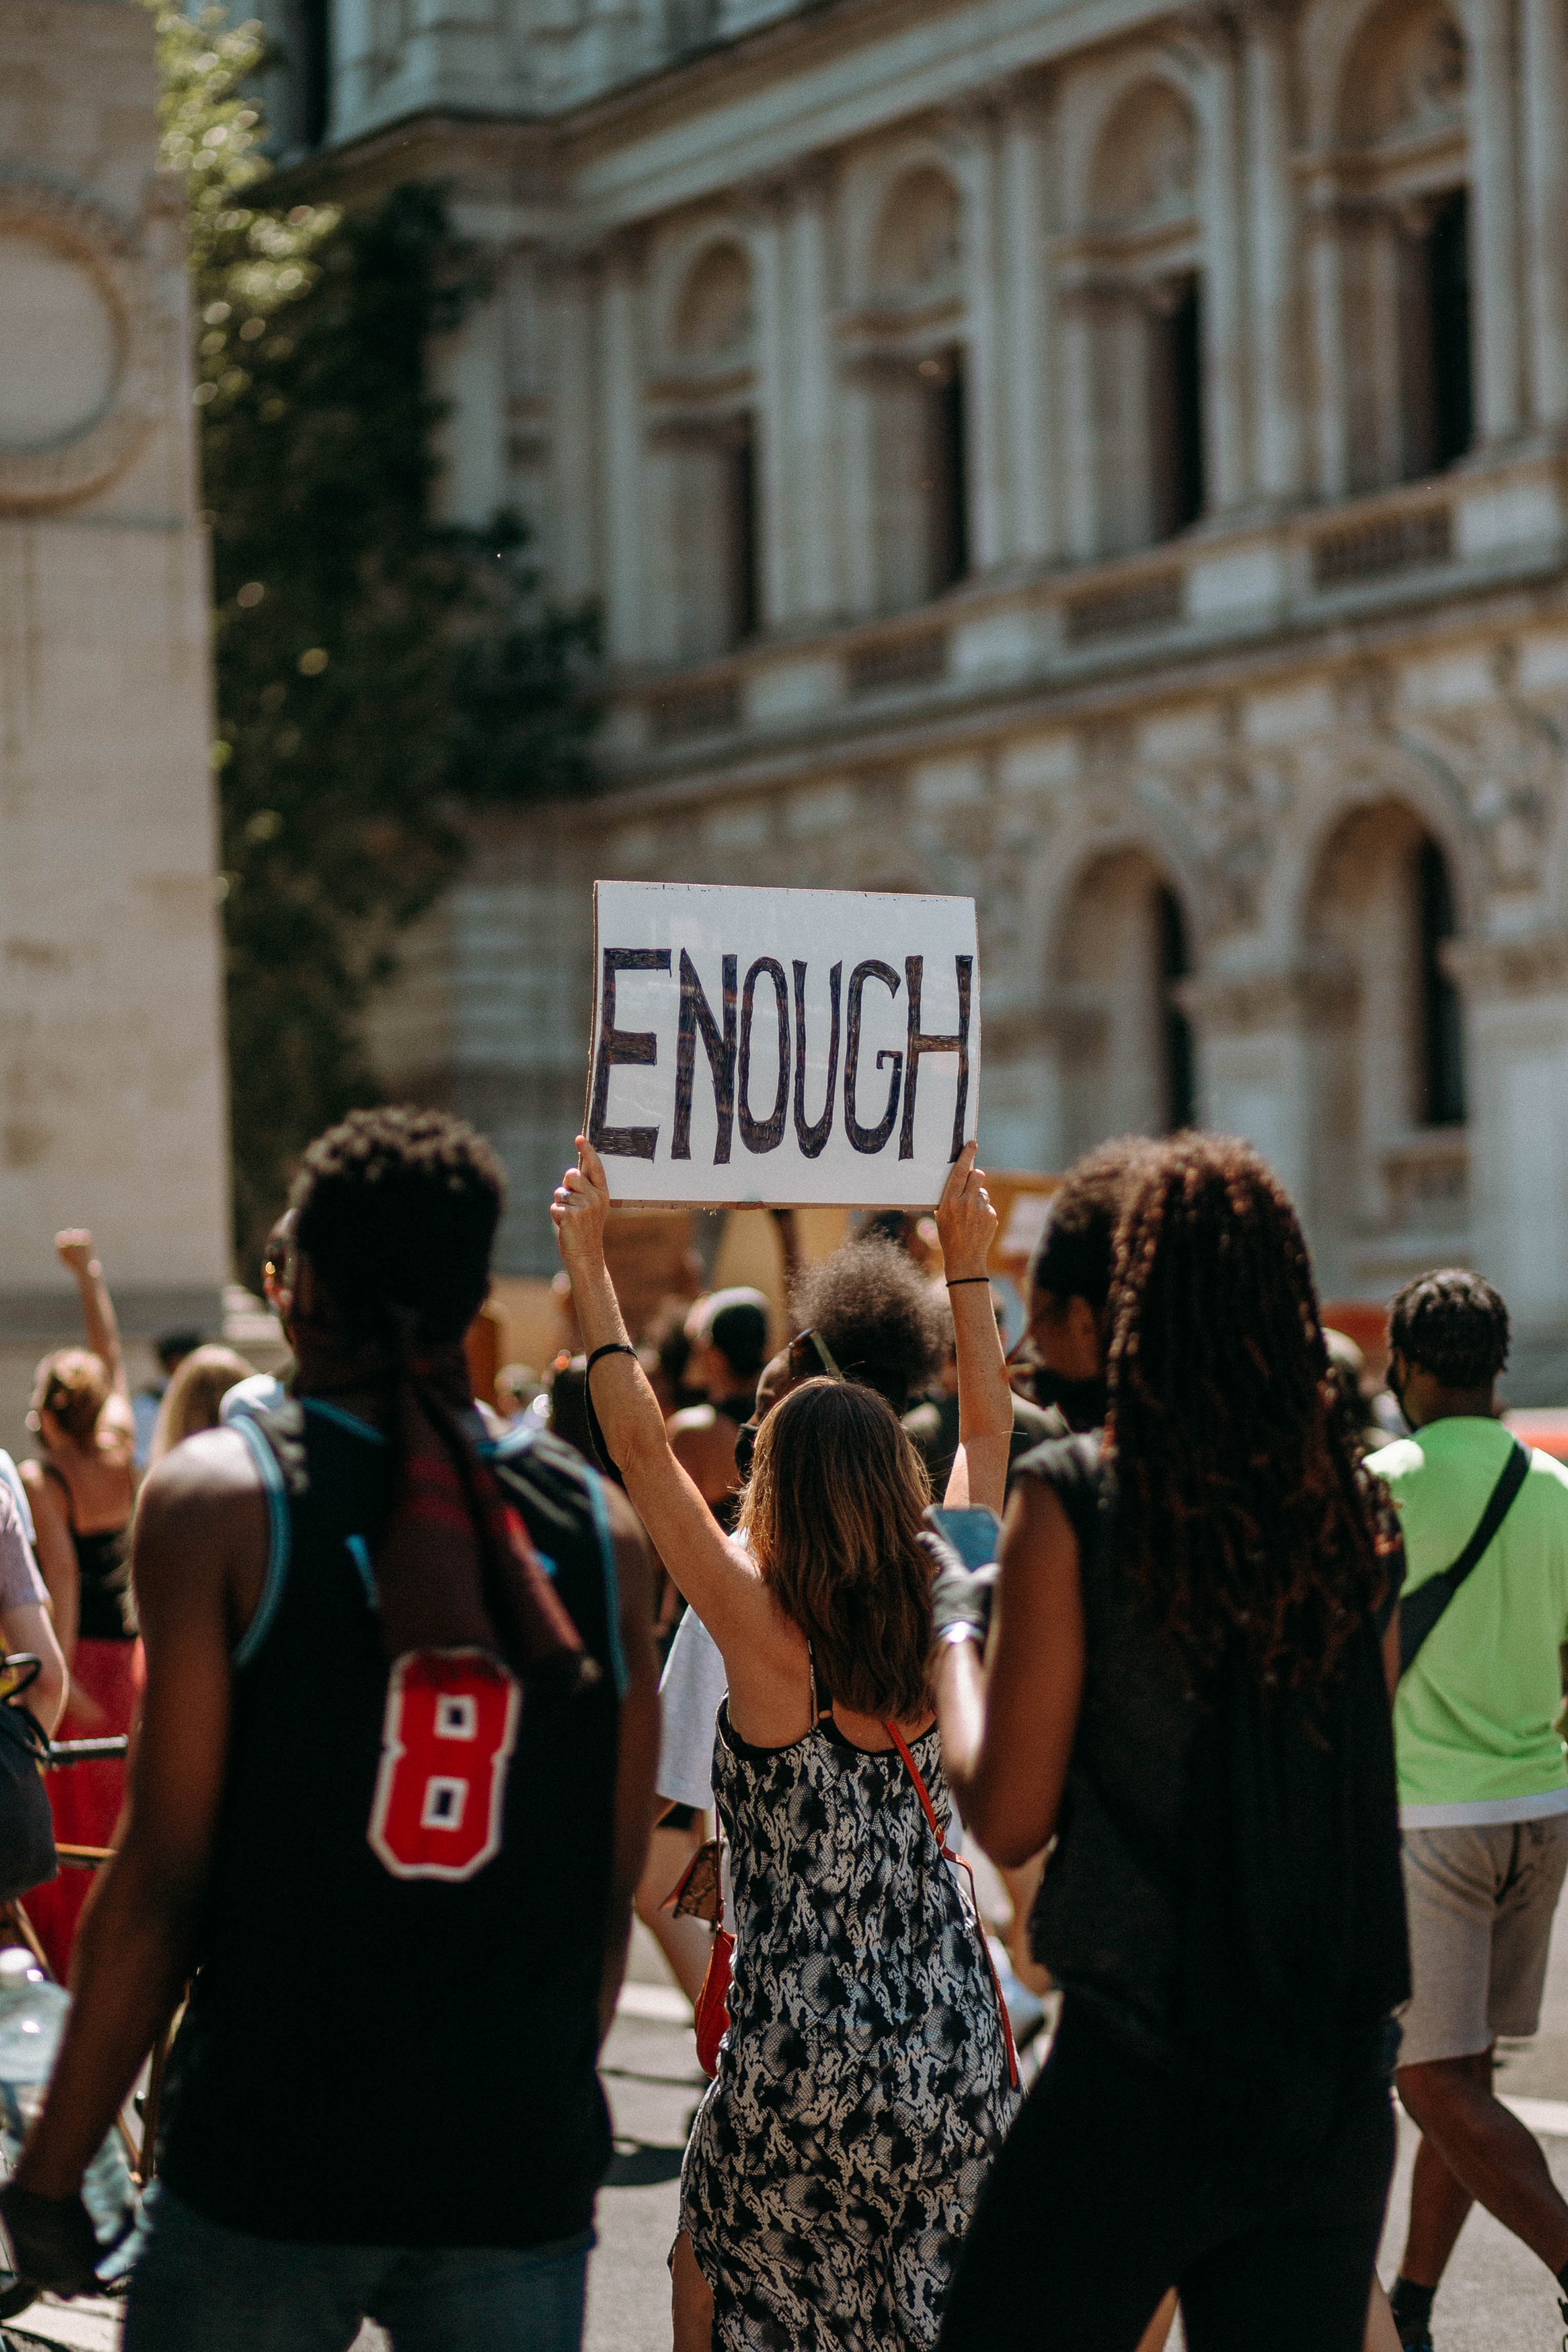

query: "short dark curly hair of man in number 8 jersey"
left=289, top=1106, right=506, bottom=1343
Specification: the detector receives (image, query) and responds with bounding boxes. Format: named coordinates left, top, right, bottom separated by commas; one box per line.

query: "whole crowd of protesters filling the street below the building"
left=0, top=1110, right=1568, bottom=2352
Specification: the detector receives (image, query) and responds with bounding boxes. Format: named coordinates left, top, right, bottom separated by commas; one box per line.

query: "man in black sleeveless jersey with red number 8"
left=3, top=1110, right=658, bottom=2352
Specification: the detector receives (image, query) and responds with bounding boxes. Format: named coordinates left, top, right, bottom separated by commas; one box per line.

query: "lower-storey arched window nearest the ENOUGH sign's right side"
left=1058, top=849, right=1196, bottom=1160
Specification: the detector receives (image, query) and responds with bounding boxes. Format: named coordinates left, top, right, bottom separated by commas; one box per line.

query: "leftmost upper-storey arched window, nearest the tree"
left=663, top=240, right=762, bottom=661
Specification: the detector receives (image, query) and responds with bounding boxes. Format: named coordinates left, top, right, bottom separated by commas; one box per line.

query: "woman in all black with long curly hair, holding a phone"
left=933, top=1136, right=1408, bottom=2352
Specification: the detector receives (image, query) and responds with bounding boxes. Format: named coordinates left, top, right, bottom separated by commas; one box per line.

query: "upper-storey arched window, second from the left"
left=865, top=165, right=969, bottom=611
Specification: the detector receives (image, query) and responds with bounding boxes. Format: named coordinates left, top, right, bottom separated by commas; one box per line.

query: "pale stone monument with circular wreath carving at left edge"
left=0, top=0, right=228, bottom=1420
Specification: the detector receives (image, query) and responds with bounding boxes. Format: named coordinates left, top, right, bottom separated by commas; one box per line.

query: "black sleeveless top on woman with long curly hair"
left=1020, top=1432, right=1408, bottom=2147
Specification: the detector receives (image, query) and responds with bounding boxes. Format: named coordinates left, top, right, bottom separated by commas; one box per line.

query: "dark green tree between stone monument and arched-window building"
left=150, top=0, right=595, bottom=1265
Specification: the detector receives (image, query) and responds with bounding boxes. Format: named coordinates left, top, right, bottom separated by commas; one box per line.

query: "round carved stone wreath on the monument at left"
left=0, top=179, right=162, bottom=515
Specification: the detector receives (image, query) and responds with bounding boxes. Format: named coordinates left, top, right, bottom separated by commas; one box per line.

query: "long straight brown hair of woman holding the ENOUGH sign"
left=741, top=1381, right=931, bottom=1724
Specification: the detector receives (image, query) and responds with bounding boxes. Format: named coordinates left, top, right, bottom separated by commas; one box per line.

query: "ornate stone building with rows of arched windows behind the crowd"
left=280, top=0, right=1568, bottom=1399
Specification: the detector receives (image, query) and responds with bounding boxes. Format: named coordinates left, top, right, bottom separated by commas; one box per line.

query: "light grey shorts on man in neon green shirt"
left=1399, top=1814, right=1568, bottom=2065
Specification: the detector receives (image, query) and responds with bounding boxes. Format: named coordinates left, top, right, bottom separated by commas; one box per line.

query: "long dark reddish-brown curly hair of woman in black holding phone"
left=1105, top=1134, right=1382, bottom=1686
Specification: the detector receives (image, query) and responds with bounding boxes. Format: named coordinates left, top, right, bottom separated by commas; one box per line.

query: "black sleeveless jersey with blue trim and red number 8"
left=160, top=1402, right=625, bottom=2246
